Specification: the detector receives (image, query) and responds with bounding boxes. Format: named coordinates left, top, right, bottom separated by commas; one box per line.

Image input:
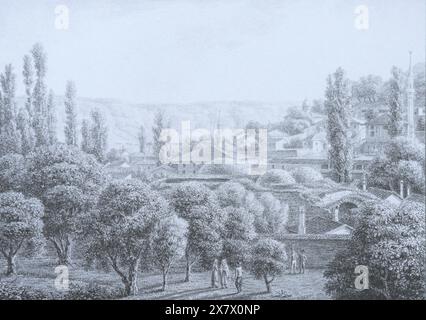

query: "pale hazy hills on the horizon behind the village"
left=18, top=96, right=298, bottom=151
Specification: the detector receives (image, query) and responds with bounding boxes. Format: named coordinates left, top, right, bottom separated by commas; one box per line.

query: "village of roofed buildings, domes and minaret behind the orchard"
left=101, top=56, right=425, bottom=267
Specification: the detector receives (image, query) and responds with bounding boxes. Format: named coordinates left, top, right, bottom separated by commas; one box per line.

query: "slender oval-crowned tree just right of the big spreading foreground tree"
left=152, top=215, right=187, bottom=291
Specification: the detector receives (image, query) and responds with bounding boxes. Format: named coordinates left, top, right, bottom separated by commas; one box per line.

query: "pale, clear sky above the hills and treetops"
left=0, top=0, right=426, bottom=103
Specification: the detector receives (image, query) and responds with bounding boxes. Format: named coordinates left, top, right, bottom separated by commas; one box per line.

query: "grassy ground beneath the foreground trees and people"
left=0, top=259, right=329, bottom=300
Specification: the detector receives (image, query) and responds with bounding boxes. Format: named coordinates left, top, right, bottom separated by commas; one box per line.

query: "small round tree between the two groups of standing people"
left=251, top=239, right=287, bottom=292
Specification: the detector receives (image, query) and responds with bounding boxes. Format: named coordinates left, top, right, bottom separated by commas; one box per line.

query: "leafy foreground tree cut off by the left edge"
left=0, top=192, right=43, bottom=275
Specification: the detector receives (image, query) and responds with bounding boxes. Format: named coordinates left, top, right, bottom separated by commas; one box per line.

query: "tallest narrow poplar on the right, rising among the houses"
left=325, top=68, right=352, bottom=182
